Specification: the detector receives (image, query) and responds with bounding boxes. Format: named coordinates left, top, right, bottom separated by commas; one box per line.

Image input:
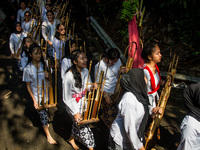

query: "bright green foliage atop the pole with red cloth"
left=121, top=0, right=137, bottom=22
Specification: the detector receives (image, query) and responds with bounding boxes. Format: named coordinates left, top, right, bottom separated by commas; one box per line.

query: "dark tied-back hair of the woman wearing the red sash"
left=141, top=42, right=158, bottom=63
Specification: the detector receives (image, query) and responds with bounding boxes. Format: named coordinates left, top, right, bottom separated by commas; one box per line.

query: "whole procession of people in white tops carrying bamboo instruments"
left=2, top=0, right=200, bottom=150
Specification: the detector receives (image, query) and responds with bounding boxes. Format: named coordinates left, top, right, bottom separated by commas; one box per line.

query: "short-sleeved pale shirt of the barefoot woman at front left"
left=22, top=62, right=46, bottom=103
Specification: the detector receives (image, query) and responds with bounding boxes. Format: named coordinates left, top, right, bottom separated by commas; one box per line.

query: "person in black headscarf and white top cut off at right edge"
left=177, top=83, right=200, bottom=150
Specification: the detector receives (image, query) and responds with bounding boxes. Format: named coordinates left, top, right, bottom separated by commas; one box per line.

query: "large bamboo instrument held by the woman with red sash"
left=145, top=54, right=179, bottom=149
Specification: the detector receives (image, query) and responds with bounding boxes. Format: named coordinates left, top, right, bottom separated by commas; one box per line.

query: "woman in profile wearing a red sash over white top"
left=141, top=42, right=162, bottom=113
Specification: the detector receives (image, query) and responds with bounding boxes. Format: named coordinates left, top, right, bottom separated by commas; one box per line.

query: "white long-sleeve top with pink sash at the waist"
left=63, top=68, right=91, bottom=117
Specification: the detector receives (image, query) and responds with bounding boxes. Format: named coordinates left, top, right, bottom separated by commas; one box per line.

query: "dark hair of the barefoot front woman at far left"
left=27, top=43, right=45, bottom=70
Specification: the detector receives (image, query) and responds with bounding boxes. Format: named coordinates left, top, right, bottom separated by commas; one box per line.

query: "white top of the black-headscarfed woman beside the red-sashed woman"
left=110, top=92, right=145, bottom=150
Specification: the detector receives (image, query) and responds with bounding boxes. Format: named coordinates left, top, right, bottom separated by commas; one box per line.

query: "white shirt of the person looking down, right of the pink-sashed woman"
left=94, top=59, right=122, bottom=93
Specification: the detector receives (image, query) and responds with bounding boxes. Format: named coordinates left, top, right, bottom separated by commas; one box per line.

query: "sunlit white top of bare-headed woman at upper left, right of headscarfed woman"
left=42, top=19, right=60, bottom=42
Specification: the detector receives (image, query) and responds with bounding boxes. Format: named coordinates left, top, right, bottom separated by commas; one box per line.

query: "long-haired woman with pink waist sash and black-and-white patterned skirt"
left=63, top=50, right=95, bottom=150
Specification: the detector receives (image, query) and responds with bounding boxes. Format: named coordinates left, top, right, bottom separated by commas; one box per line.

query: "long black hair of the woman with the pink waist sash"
left=66, top=50, right=83, bottom=88
